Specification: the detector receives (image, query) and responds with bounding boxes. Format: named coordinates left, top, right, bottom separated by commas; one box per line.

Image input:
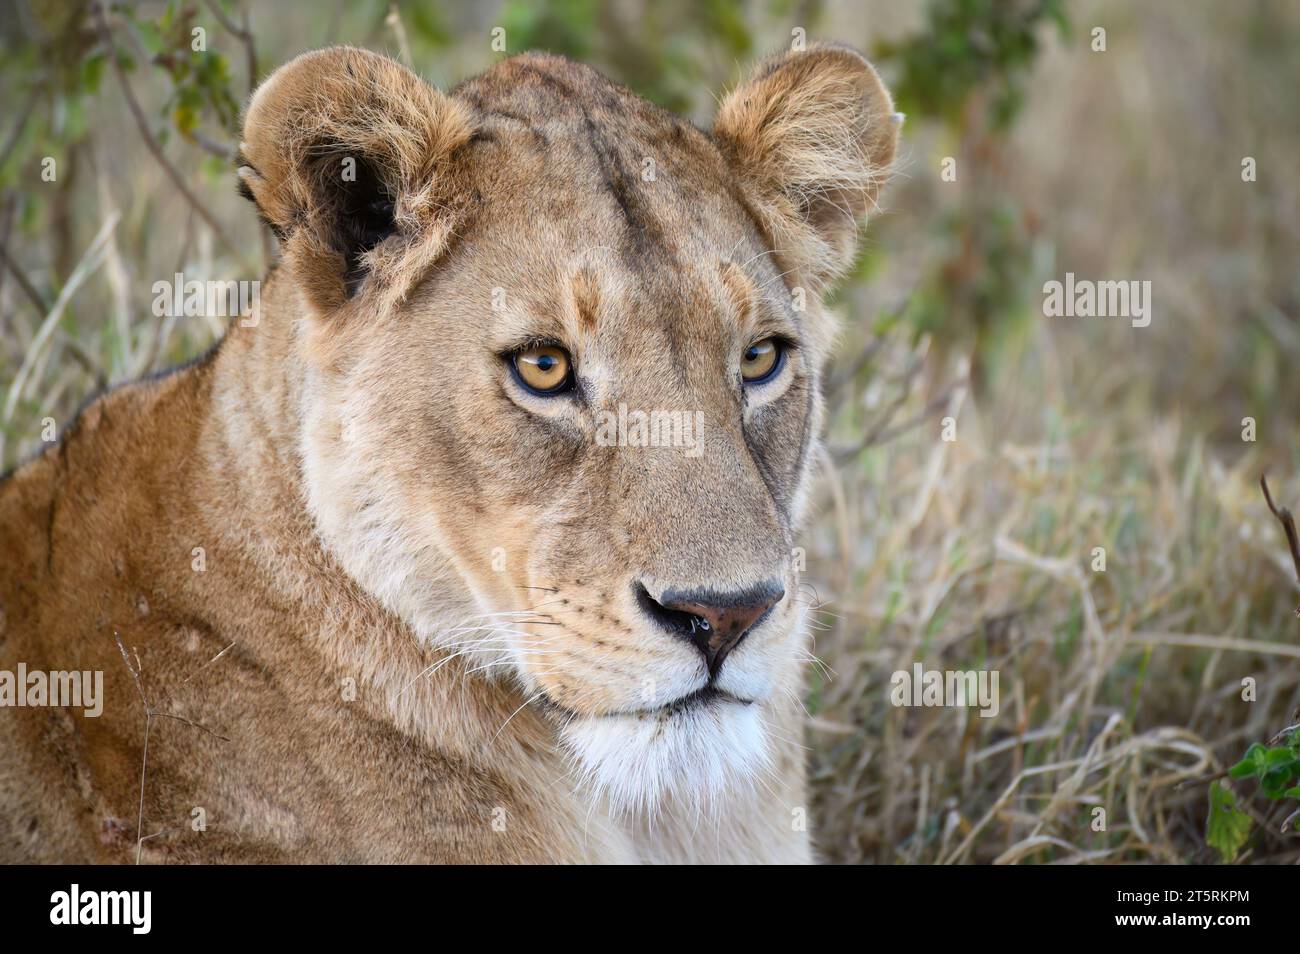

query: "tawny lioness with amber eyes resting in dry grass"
left=0, top=45, right=897, bottom=862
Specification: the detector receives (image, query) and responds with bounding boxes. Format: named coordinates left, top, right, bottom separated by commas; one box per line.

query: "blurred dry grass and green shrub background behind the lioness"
left=0, top=0, right=1300, bottom=863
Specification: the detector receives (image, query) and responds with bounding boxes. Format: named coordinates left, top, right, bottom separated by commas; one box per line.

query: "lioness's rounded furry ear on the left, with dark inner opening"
left=237, top=47, right=473, bottom=311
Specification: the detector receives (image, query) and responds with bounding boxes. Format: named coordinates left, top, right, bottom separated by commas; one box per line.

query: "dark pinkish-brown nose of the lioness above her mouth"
left=637, top=581, right=785, bottom=677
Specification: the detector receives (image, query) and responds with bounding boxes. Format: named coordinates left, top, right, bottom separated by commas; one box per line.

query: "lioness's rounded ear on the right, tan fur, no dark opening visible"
left=714, top=44, right=902, bottom=290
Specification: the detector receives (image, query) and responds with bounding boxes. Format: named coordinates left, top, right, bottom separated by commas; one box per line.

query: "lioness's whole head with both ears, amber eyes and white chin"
left=241, top=47, right=896, bottom=807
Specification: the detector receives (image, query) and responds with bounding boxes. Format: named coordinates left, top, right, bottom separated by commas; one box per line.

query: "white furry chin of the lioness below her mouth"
left=560, top=701, right=771, bottom=815
